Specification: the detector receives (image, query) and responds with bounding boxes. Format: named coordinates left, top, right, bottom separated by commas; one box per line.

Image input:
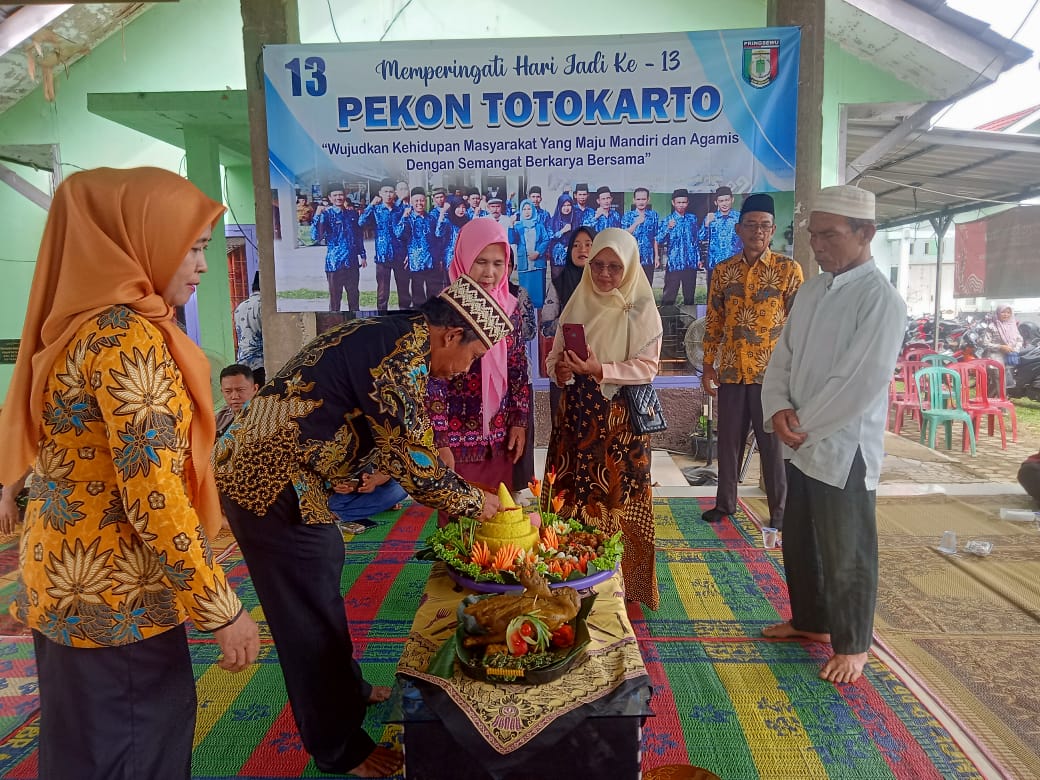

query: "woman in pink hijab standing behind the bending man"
left=426, top=218, right=534, bottom=524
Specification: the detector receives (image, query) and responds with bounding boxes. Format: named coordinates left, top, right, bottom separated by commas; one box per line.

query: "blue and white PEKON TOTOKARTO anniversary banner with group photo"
left=264, top=32, right=799, bottom=374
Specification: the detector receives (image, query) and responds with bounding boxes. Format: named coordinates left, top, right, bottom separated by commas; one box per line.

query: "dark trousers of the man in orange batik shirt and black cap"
left=716, top=383, right=787, bottom=528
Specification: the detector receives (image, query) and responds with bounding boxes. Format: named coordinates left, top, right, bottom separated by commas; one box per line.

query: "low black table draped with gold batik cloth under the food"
left=391, top=563, right=652, bottom=780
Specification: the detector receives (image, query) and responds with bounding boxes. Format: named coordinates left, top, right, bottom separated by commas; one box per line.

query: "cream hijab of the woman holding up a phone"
left=560, top=228, right=661, bottom=398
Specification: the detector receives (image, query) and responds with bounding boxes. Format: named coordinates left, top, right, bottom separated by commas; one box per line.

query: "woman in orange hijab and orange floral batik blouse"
left=0, top=168, right=260, bottom=780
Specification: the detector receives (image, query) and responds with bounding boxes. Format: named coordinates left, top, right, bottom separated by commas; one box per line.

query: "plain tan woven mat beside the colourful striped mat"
left=748, top=495, right=1040, bottom=778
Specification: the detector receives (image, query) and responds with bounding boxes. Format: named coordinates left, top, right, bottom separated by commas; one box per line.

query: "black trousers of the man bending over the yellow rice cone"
left=224, top=485, right=375, bottom=773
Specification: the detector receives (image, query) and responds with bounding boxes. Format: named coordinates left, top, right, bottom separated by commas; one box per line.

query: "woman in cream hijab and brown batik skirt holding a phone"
left=546, top=228, right=661, bottom=609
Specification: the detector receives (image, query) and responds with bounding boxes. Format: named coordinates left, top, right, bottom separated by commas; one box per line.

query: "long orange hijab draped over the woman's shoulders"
left=0, top=167, right=224, bottom=539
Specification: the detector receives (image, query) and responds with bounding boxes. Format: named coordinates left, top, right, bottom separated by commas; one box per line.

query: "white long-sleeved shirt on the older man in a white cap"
left=762, top=259, right=906, bottom=490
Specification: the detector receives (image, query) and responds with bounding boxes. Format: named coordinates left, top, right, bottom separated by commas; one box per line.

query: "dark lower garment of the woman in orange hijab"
left=32, top=625, right=197, bottom=780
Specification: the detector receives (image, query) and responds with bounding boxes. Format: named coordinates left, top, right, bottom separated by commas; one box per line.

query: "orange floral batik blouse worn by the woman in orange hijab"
left=11, top=306, right=241, bottom=647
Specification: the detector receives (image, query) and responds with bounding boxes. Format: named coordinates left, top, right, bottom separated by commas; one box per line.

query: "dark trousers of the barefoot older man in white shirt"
left=783, top=451, right=878, bottom=655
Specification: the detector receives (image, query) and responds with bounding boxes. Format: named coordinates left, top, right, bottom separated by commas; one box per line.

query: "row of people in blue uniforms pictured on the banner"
left=303, top=179, right=742, bottom=314
